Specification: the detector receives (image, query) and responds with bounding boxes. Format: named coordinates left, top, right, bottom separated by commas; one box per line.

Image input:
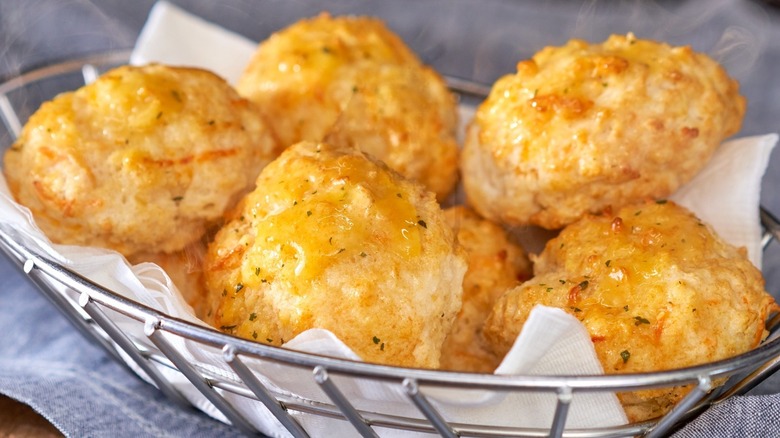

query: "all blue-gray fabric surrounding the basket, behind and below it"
left=0, top=0, right=780, bottom=437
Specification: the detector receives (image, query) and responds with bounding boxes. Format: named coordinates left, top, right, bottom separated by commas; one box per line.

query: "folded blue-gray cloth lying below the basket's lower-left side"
left=0, top=259, right=241, bottom=437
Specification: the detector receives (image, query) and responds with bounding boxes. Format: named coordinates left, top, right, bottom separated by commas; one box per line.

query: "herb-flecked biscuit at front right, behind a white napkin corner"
left=484, top=201, right=777, bottom=421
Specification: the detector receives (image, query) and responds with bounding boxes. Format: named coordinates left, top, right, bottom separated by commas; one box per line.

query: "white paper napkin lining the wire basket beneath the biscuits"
left=0, top=2, right=777, bottom=436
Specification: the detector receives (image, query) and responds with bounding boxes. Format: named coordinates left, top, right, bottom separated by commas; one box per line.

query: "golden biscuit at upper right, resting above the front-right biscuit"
left=461, top=34, right=745, bottom=229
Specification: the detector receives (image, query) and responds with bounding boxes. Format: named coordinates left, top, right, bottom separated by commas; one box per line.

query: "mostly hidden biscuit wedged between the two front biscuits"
left=441, top=206, right=531, bottom=373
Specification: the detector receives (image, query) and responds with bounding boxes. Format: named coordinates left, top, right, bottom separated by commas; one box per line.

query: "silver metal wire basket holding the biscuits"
left=0, top=52, right=780, bottom=437
